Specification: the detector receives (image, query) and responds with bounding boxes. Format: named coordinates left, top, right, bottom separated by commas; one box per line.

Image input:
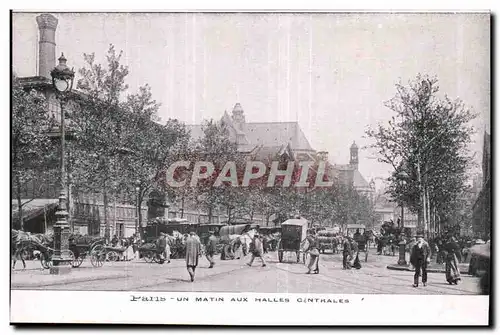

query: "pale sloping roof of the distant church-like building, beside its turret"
left=187, top=122, right=314, bottom=151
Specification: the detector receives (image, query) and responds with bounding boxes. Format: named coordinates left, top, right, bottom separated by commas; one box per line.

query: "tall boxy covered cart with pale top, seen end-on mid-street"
left=278, top=219, right=308, bottom=263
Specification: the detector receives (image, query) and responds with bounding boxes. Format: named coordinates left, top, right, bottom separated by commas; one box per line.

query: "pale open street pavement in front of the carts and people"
left=11, top=253, right=479, bottom=295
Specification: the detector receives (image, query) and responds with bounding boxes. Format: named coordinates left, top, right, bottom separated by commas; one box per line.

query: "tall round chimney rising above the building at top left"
left=36, top=14, right=57, bottom=79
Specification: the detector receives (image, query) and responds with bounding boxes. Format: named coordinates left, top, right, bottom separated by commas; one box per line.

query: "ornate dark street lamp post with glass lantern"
left=50, top=54, right=75, bottom=274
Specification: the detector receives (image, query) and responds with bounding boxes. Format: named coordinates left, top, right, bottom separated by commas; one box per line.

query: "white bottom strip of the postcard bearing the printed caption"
left=11, top=290, right=489, bottom=326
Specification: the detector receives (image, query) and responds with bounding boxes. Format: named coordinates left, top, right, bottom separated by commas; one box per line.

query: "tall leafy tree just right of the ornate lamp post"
left=71, top=45, right=132, bottom=239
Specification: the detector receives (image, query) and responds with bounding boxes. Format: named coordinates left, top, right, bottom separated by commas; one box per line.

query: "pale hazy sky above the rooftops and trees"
left=12, top=13, right=490, bottom=189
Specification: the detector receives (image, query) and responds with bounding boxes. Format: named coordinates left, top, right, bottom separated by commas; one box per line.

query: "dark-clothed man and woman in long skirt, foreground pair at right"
left=410, top=235, right=461, bottom=287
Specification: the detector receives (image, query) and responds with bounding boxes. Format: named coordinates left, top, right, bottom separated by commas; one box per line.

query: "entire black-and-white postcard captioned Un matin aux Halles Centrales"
left=10, top=11, right=492, bottom=325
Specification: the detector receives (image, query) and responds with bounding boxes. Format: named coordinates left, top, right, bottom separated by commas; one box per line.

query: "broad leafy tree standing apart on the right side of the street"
left=367, top=75, right=476, bottom=235
